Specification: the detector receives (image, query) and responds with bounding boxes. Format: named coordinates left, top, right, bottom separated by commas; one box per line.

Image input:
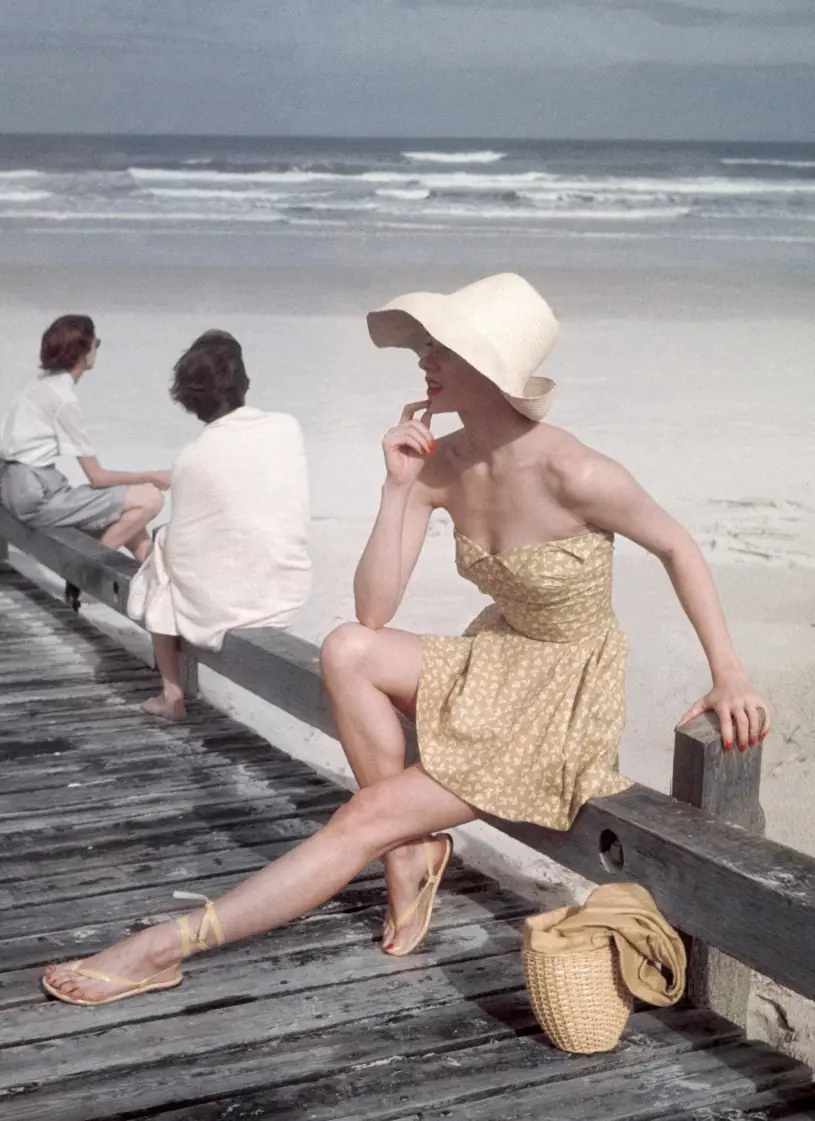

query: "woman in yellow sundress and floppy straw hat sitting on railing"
left=44, top=274, right=769, bottom=1003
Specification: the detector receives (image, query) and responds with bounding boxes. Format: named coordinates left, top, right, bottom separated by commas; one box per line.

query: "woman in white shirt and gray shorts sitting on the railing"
left=0, top=315, right=169, bottom=561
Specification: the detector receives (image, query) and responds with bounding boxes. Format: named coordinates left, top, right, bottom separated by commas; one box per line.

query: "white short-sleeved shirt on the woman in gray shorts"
left=0, top=373, right=95, bottom=467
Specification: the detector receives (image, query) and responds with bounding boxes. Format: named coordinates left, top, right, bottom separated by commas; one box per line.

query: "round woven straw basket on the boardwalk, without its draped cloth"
left=524, top=915, right=633, bottom=1055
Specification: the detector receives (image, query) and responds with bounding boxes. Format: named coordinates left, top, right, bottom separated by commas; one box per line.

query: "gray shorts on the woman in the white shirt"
left=0, top=461, right=127, bottom=535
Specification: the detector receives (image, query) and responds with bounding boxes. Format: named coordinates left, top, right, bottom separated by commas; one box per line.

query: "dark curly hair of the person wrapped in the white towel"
left=169, top=331, right=249, bottom=424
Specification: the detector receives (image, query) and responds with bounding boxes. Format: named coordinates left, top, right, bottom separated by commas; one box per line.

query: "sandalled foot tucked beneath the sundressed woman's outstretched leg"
left=382, top=834, right=453, bottom=956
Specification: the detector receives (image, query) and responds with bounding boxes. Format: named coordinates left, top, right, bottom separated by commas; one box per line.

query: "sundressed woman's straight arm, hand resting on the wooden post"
left=562, top=454, right=771, bottom=751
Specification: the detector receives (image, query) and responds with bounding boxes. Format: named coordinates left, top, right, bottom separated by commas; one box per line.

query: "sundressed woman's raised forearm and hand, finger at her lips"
left=354, top=401, right=435, bottom=630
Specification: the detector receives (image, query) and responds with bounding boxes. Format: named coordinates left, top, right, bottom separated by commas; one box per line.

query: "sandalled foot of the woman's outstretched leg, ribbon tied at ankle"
left=44, top=923, right=182, bottom=1003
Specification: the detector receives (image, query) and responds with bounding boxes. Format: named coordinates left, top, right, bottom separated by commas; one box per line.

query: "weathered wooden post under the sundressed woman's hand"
left=670, top=713, right=765, bottom=1027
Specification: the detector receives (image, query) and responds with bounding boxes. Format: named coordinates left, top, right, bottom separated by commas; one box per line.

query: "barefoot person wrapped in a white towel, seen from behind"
left=128, top=331, right=312, bottom=720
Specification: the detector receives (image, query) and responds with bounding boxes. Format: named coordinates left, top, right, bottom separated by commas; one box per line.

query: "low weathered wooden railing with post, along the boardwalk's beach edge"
left=0, top=509, right=815, bottom=1022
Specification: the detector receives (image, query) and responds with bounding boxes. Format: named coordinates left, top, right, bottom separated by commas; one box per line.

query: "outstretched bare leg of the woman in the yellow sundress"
left=46, top=766, right=475, bottom=1000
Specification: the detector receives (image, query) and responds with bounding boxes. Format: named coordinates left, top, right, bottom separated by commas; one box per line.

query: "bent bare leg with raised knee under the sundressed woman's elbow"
left=322, top=623, right=443, bottom=949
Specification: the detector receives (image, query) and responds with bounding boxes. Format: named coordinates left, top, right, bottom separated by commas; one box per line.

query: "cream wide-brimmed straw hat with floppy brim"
left=368, top=272, right=559, bottom=420
